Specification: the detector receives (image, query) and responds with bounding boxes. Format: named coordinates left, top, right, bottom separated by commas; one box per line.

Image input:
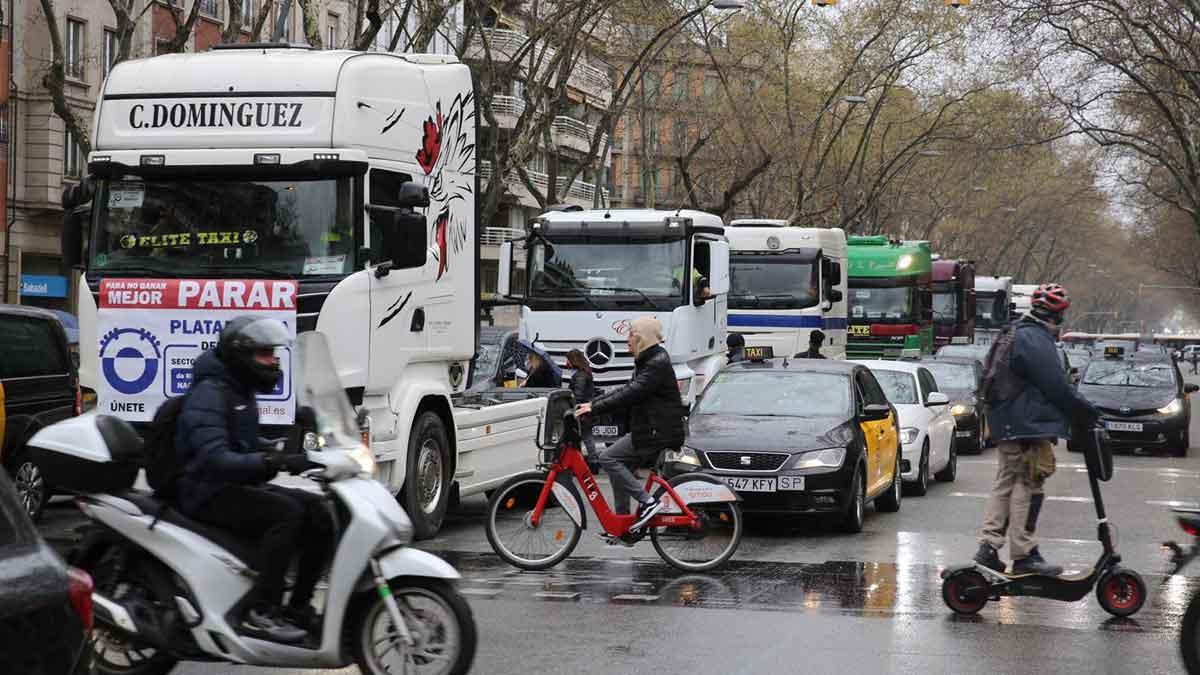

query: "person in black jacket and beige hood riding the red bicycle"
left=575, top=317, right=684, bottom=533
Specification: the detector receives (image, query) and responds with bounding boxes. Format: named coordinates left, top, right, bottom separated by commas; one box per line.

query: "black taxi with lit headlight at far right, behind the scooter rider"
left=1067, top=346, right=1200, bottom=456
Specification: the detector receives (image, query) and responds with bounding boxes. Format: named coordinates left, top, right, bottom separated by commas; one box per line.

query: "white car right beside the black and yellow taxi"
left=858, top=360, right=958, bottom=496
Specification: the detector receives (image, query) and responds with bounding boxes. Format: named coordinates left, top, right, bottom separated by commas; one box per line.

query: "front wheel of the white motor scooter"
left=353, top=578, right=478, bottom=675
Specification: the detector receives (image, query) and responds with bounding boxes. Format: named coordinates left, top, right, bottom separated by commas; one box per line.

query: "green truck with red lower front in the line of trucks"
left=846, top=235, right=934, bottom=359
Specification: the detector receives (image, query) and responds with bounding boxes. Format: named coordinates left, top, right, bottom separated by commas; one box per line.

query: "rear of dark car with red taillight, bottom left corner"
left=0, top=472, right=92, bottom=675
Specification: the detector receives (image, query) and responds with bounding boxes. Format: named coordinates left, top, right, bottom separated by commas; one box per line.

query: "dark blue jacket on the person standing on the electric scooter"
left=988, top=317, right=1099, bottom=441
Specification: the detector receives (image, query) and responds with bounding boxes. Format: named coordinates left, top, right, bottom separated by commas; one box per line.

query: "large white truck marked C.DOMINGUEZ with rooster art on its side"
left=57, top=44, right=545, bottom=537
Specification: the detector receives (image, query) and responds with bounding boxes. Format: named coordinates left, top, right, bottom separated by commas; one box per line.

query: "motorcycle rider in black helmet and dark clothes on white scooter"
left=175, top=316, right=331, bottom=643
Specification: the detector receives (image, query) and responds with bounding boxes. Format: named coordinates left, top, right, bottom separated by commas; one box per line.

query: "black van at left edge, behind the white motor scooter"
left=0, top=305, right=82, bottom=520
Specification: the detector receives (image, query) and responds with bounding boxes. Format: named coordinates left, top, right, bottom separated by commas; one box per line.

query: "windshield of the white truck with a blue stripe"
left=730, top=253, right=821, bottom=310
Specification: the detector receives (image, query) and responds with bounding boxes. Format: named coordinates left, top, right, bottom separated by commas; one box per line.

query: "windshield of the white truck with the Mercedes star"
left=529, top=240, right=686, bottom=306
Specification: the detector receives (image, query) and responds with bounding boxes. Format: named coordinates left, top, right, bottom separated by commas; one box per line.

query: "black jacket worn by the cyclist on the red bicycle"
left=592, top=345, right=685, bottom=452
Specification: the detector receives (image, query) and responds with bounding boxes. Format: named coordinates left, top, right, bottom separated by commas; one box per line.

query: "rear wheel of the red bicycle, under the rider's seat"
left=650, top=477, right=742, bottom=572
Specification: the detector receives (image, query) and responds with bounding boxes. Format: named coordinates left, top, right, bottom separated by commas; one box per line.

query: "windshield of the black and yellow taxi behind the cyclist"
left=696, top=371, right=850, bottom=418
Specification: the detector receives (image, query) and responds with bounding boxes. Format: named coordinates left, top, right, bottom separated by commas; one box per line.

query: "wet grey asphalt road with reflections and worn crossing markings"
left=35, top=369, right=1200, bottom=674
